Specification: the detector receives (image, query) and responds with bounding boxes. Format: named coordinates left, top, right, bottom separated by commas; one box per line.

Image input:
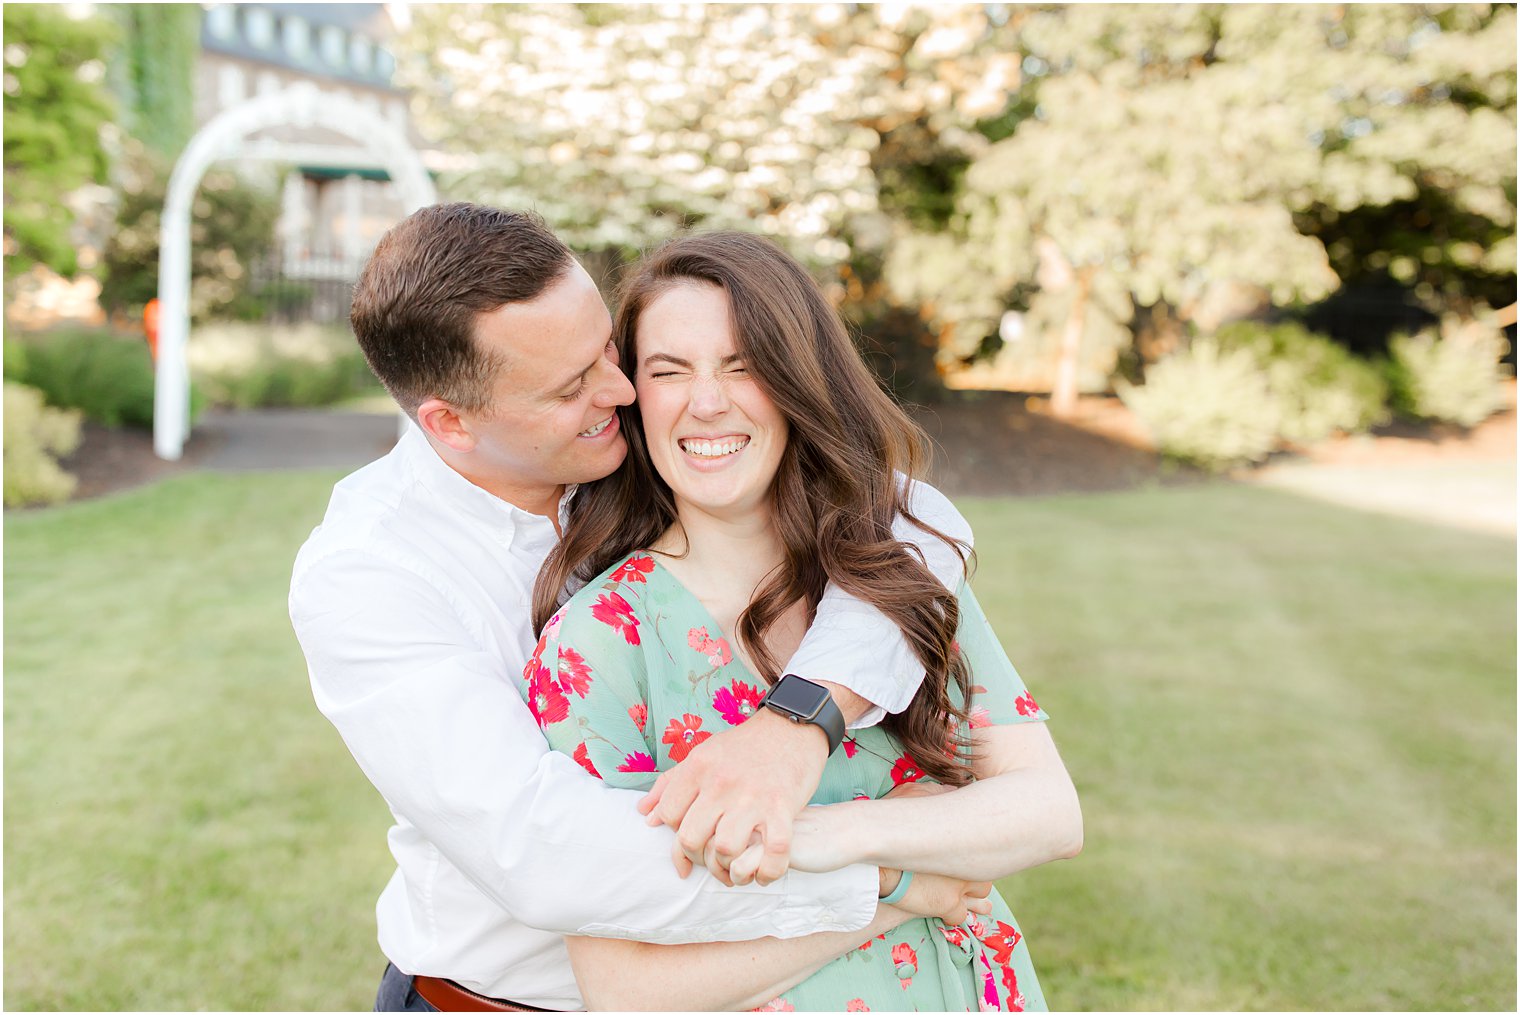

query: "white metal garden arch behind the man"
left=154, top=82, right=438, bottom=460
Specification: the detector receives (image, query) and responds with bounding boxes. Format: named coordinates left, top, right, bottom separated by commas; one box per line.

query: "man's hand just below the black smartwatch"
left=638, top=710, right=828, bottom=884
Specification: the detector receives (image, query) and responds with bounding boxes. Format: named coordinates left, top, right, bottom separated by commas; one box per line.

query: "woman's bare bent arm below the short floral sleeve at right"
left=792, top=722, right=1082, bottom=881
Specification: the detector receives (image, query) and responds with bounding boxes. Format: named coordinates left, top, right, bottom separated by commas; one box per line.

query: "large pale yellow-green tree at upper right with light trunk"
left=888, top=5, right=1515, bottom=412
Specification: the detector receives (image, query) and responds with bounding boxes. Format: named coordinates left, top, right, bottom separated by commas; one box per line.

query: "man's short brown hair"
left=350, top=202, right=575, bottom=416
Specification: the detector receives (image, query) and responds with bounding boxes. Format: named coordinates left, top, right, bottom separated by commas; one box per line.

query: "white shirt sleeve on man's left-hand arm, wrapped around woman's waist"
left=290, top=550, right=877, bottom=944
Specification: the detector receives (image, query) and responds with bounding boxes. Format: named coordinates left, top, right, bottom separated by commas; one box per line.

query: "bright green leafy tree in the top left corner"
left=5, top=3, right=114, bottom=280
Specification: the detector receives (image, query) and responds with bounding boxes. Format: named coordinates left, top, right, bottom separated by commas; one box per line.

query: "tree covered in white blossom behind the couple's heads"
left=400, top=5, right=1018, bottom=266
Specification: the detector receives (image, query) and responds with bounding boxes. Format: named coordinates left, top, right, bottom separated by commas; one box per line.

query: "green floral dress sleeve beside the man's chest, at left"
left=518, top=588, right=658, bottom=790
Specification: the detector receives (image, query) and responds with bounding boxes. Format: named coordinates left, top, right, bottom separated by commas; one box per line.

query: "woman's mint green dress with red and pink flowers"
left=521, top=553, right=1046, bottom=1012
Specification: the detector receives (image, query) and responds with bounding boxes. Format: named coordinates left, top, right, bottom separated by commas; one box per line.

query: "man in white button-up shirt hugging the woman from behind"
left=290, top=204, right=970, bottom=1010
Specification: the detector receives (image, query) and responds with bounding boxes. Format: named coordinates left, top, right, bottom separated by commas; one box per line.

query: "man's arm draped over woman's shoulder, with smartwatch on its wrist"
left=638, top=480, right=971, bottom=884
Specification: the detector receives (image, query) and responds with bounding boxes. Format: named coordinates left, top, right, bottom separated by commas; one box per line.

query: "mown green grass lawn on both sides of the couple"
left=5, top=474, right=1515, bottom=1010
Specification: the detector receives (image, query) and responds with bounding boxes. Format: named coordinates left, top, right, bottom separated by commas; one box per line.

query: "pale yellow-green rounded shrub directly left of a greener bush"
left=1116, top=339, right=1280, bottom=471
